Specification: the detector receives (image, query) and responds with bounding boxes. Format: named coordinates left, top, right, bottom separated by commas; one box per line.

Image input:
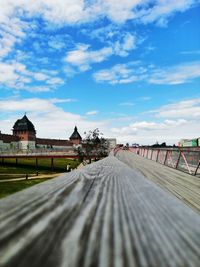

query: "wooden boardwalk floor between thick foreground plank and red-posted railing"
left=116, top=150, right=200, bottom=212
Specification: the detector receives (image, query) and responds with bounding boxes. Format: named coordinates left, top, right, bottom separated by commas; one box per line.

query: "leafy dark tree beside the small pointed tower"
left=76, top=128, right=108, bottom=163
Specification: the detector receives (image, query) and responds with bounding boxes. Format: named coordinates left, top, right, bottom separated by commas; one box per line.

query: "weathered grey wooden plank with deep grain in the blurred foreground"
left=0, top=156, right=200, bottom=267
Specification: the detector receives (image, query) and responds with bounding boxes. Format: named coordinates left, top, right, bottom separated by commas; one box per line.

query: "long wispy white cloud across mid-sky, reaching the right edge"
left=93, top=61, right=200, bottom=85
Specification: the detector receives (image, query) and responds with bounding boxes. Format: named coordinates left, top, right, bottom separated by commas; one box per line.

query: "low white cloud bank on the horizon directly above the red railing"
left=111, top=119, right=200, bottom=145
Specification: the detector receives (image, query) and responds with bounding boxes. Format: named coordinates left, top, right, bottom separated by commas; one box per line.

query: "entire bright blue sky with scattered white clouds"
left=0, top=0, right=200, bottom=147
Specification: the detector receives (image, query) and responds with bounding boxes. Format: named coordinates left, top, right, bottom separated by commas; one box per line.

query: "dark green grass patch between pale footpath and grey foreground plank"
left=0, top=178, right=53, bottom=198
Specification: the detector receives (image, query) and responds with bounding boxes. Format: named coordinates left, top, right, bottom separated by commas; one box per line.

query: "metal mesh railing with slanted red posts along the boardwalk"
left=129, top=147, right=200, bottom=176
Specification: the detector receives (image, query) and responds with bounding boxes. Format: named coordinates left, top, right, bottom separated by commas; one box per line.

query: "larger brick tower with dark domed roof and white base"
left=13, top=114, right=36, bottom=149
